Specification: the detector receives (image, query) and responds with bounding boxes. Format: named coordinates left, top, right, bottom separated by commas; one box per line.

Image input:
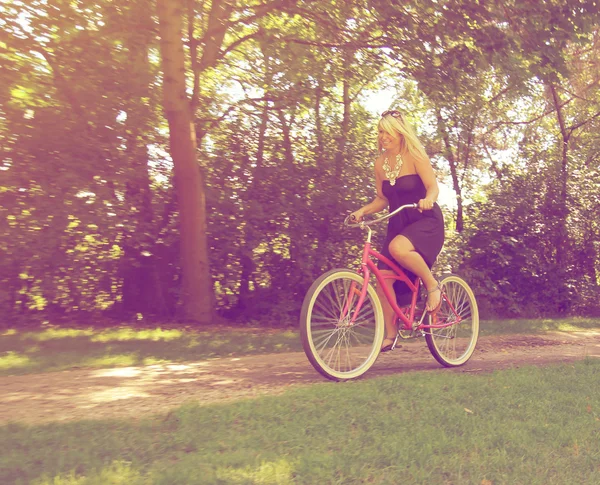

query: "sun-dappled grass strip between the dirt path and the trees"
left=0, top=318, right=600, bottom=375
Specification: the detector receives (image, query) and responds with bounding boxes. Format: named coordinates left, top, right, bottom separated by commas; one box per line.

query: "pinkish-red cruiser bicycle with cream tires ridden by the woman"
left=300, top=204, right=479, bottom=381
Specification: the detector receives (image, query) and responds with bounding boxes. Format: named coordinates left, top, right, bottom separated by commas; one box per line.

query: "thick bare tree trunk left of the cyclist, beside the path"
left=157, top=0, right=214, bottom=323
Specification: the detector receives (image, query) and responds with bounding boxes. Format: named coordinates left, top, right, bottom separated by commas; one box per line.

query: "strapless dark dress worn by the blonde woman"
left=377, top=174, right=444, bottom=306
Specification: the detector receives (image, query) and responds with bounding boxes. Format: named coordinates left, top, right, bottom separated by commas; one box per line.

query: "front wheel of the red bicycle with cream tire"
left=300, top=269, right=384, bottom=381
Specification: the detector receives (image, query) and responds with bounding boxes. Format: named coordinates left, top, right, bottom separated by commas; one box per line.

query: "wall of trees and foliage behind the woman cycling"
left=0, top=0, right=600, bottom=325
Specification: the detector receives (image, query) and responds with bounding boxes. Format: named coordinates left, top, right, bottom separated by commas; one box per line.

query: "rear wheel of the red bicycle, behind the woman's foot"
left=425, top=274, right=479, bottom=367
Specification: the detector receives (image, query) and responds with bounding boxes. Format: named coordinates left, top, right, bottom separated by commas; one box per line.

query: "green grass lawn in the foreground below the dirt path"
left=0, top=359, right=600, bottom=485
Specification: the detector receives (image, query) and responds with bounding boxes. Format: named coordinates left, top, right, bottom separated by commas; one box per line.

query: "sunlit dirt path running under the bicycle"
left=0, top=332, right=600, bottom=424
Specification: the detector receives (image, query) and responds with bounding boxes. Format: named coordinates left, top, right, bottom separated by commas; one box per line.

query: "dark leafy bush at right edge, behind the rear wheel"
left=452, top=163, right=600, bottom=317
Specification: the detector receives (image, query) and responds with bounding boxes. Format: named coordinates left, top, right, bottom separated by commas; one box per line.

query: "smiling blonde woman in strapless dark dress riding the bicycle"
left=351, top=110, right=444, bottom=352
